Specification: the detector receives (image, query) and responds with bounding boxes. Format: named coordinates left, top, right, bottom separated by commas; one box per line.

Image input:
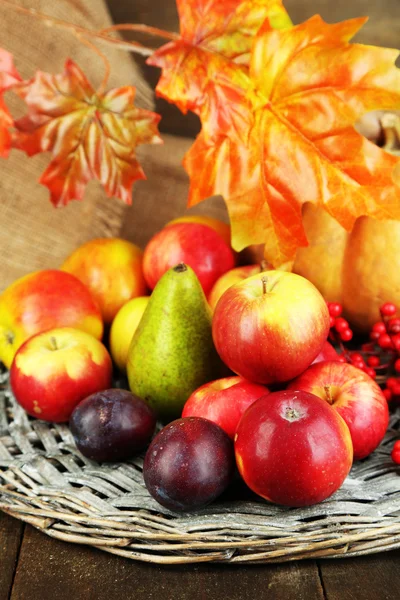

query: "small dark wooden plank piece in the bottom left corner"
left=0, top=512, right=24, bottom=600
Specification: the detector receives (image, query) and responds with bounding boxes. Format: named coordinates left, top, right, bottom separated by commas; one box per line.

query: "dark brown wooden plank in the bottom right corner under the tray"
left=319, top=550, right=400, bottom=600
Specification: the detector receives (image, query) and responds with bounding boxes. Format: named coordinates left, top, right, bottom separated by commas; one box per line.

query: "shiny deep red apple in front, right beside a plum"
left=235, top=391, right=353, bottom=507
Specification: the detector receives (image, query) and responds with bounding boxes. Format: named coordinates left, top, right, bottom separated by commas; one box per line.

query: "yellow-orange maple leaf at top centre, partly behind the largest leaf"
left=147, top=0, right=292, bottom=124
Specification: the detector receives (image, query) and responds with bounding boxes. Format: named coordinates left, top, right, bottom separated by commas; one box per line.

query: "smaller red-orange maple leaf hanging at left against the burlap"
left=14, top=60, right=162, bottom=206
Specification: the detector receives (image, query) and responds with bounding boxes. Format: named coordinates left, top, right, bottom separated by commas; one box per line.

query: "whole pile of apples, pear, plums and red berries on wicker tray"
left=0, top=217, right=400, bottom=511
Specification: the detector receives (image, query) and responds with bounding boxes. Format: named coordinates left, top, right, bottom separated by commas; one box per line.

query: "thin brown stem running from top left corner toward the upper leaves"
left=0, top=0, right=158, bottom=56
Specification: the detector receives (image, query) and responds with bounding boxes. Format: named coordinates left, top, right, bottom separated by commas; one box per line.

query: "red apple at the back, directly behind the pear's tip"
left=143, top=222, right=235, bottom=295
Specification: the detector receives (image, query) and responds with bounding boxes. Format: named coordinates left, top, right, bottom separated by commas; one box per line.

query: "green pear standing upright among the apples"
left=127, top=264, right=221, bottom=422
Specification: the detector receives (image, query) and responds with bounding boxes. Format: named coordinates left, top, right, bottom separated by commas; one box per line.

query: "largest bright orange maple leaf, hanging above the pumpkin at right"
left=152, top=7, right=400, bottom=266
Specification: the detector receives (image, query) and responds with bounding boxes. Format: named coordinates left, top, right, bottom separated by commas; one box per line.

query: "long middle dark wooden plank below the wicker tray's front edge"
left=10, top=526, right=324, bottom=600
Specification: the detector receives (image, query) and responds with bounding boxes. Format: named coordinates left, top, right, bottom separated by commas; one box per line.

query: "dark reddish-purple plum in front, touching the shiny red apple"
left=143, top=417, right=235, bottom=511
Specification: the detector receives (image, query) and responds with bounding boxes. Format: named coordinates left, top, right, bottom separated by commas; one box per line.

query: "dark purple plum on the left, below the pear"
left=69, top=389, right=156, bottom=462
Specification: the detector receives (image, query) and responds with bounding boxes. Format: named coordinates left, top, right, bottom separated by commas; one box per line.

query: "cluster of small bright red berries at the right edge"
left=328, top=302, right=400, bottom=464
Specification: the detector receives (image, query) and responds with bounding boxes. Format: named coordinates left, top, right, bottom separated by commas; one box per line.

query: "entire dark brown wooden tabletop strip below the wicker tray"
left=0, top=513, right=400, bottom=600
